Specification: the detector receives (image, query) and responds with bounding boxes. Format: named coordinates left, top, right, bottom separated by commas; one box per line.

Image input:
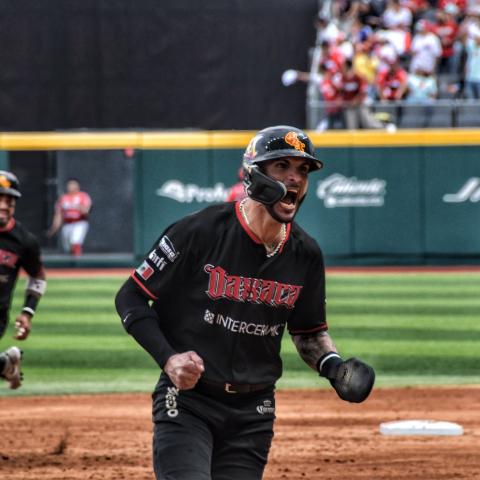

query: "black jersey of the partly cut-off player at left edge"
left=0, top=219, right=43, bottom=310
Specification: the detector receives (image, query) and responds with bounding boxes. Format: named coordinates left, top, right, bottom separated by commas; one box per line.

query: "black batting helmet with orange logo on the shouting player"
left=243, top=125, right=323, bottom=205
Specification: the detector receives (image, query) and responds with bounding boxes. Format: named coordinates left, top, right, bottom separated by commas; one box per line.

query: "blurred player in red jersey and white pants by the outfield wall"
left=47, top=178, right=92, bottom=256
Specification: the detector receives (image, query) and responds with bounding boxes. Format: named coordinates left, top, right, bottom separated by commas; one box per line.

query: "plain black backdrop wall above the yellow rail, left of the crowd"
left=0, top=0, right=318, bottom=131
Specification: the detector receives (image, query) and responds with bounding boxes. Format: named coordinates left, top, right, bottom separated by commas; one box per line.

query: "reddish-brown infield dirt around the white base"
left=0, top=384, right=480, bottom=480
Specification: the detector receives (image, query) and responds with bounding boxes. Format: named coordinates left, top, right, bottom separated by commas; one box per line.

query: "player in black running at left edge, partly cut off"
left=0, top=170, right=47, bottom=389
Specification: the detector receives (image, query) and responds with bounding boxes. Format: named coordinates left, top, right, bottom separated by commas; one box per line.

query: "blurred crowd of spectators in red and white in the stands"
left=284, top=0, right=480, bottom=128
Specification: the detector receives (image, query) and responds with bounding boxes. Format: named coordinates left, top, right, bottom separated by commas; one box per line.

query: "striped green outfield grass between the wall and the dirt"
left=0, top=273, right=480, bottom=396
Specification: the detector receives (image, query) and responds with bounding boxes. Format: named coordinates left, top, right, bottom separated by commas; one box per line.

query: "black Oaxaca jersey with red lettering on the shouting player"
left=132, top=203, right=327, bottom=384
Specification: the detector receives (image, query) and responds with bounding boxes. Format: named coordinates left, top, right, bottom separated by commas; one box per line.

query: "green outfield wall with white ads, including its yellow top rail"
left=0, top=130, right=480, bottom=265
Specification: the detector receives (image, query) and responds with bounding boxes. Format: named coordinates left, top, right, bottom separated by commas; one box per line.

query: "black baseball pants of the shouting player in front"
left=153, top=375, right=275, bottom=480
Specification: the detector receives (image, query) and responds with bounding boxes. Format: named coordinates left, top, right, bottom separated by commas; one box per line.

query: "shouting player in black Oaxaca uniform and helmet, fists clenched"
left=116, top=126, right=374, bottom=480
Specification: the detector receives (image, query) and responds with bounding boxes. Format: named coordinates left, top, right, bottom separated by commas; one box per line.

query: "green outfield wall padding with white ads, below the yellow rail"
left=135, top=131, right=480, bottom=265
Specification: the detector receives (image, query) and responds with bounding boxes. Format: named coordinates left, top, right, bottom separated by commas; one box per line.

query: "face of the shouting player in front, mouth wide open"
left=265, top=157, right=310, bottom=222
